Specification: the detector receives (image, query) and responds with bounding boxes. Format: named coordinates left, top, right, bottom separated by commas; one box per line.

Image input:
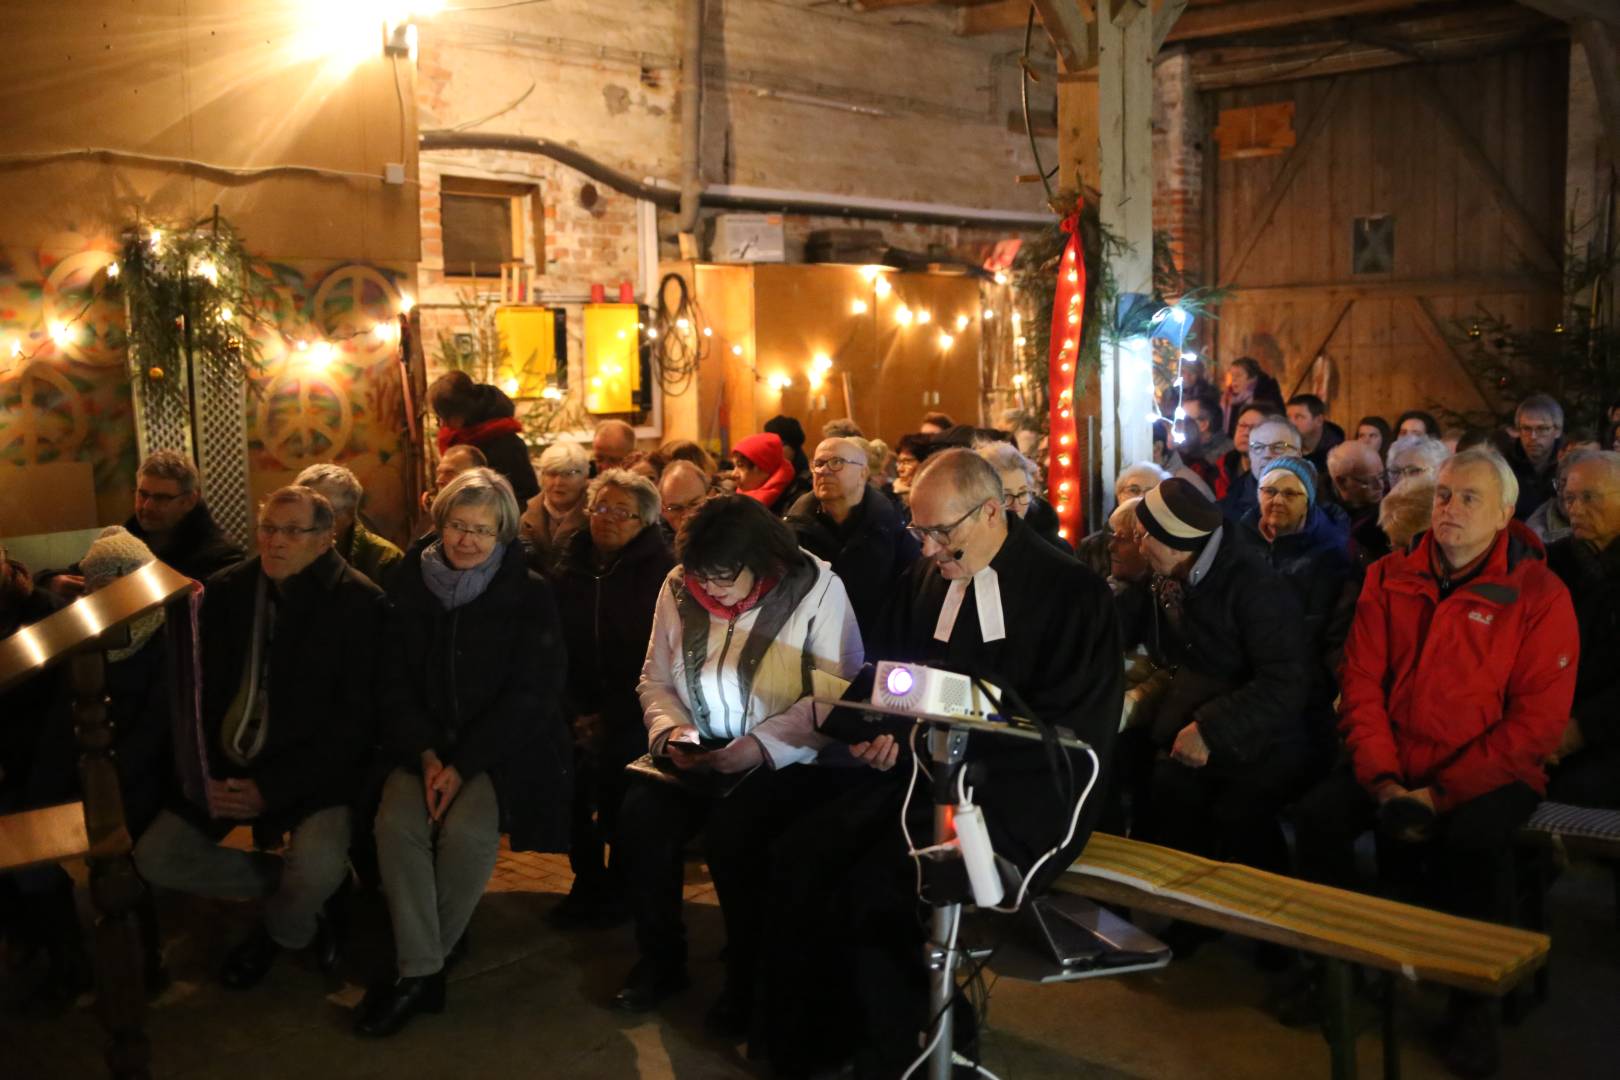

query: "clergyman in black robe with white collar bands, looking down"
left=750, top=449, right=1124, bottom=1075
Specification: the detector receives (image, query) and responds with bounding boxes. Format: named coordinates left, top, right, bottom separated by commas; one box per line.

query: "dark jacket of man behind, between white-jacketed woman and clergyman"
left=787, top=484, right=922, bottom=638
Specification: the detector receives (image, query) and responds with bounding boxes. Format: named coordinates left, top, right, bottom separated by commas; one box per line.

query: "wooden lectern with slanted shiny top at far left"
left=0, top=562, right=196, bottom=1080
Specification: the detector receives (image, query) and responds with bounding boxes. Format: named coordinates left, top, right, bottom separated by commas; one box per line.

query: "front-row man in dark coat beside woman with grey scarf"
left=134, top=486, right=384, bottom=989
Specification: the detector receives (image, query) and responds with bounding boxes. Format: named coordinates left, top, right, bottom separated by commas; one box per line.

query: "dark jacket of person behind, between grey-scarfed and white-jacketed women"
left=551, top=525, right=676, bottom=761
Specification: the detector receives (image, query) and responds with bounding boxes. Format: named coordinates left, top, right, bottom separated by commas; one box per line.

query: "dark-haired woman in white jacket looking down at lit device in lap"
left=614, top=495, right=865, bottom=1035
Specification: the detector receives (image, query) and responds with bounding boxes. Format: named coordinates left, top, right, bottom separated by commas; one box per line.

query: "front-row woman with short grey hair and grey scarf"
left=355, top=468, right=573, bottom=1036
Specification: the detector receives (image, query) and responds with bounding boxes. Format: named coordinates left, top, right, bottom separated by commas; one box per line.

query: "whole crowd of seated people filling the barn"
left=0, top=386, right=1620, bottom=1077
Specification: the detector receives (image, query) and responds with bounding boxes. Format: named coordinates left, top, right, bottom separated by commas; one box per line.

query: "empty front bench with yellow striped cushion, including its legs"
left=1051, top=832, right=1550, bottom=1080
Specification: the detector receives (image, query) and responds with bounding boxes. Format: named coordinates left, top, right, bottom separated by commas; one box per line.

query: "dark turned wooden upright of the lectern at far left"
left=70, top=647, right=152, bottom=1080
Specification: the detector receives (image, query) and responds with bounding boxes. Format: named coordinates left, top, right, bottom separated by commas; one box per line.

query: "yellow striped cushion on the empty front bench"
left=1053, top=832, right=1550, bottom=993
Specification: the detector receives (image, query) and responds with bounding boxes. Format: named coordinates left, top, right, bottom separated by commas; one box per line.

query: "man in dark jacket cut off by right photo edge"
left=1547, top=450, right=1620, bottom=808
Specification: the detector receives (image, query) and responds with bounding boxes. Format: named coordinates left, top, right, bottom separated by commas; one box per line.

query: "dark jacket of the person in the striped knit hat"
left=1150, top=525, right=1311, bottom=766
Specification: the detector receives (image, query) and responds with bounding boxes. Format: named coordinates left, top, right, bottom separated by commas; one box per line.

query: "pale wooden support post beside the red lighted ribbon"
left=1097, top=0, right=1153, bottom=482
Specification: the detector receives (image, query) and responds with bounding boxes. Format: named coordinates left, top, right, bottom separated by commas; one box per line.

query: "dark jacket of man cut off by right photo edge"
left=1547, top=536, right=1620, bottom=757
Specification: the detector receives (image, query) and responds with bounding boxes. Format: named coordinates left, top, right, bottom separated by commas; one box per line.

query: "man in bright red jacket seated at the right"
left=1298, top=449, right=1580, bottom=1075
